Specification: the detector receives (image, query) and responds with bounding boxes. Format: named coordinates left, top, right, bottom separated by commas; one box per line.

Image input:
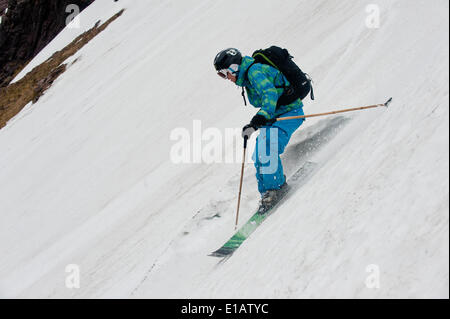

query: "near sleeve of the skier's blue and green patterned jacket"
left=248, top=65, right=278, bottom=120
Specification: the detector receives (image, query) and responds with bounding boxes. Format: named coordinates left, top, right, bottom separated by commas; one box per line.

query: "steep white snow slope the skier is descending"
left=0, top=0, right=449, bottom=298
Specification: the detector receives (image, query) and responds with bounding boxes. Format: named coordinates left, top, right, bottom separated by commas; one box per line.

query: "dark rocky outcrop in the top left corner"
left=0, top=0, right=94, bottom=87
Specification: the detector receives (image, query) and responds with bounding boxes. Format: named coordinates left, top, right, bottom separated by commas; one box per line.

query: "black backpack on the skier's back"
left=245, top=46, right=314, bottom=107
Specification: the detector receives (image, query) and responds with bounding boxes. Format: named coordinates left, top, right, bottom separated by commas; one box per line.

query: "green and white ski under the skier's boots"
left=209, top=162, right=317, bottom=257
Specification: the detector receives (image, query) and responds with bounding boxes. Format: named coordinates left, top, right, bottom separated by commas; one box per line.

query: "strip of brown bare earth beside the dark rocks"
left=0, top=10, right=125, bottom=129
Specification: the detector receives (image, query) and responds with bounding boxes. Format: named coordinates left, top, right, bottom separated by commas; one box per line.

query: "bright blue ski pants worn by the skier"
left=252, top=108, right=304, bottom=194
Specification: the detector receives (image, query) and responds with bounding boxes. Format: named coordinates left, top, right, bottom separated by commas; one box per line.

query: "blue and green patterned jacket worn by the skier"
left=236, top=56, right=303, bottom=120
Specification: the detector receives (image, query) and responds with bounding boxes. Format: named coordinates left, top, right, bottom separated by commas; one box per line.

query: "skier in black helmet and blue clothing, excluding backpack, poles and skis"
left=214, top=48, right=304, bottom=212
